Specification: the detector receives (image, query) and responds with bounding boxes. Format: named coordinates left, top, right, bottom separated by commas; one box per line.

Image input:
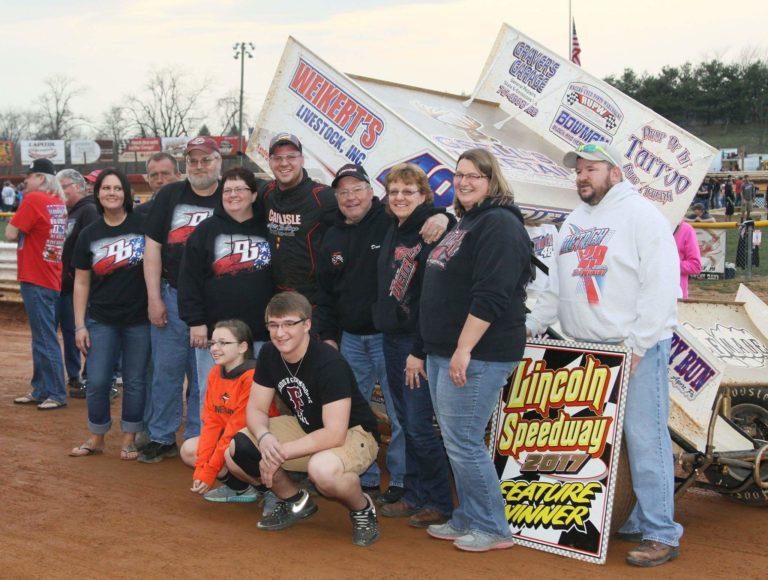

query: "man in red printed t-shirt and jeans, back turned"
left=5, top=159, right=67, bottom=411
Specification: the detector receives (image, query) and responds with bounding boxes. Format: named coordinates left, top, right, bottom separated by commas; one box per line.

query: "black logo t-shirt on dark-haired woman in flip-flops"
left=72, top=213, right=147, bottom=326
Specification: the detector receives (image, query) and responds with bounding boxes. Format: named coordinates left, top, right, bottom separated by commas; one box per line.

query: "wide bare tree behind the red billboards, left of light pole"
left=126, top=68, right=207, bottom=137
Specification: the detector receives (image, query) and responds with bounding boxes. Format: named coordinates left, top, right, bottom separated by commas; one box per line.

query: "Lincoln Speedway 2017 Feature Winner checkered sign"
left=492, top=340, right=631, bottom=564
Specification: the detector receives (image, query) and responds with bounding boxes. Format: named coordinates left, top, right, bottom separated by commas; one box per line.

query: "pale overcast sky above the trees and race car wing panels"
left=0, top=0, right=768, bottom=137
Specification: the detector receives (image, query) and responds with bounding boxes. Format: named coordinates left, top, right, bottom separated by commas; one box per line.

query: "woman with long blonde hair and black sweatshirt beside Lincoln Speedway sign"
left=419, top=149, right=531, bottom=552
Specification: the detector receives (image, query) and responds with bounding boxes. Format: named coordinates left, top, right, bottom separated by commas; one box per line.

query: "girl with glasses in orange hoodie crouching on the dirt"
left=181, top=320, right=277, bottom=503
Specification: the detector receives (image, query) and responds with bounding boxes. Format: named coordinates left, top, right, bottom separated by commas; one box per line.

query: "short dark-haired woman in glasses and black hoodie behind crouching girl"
left=179, top=167, right=274, bottom=405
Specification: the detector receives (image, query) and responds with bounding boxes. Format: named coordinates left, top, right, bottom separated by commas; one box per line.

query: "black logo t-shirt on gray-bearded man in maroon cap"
left=144, top=179, right=221, bottom=288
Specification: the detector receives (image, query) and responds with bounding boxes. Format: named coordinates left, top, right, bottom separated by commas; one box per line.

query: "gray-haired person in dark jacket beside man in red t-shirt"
left=56, top=169, right=99, bottom=399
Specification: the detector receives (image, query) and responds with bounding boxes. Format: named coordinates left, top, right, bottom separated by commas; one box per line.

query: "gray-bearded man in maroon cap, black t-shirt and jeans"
left=138, top=137, right=221, bottom=463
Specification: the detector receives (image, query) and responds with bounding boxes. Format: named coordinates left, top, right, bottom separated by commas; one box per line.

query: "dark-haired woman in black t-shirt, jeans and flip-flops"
left=69, top=169, right=150, bottom=460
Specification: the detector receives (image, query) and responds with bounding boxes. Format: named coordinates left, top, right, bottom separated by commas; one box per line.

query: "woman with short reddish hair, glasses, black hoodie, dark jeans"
left=373, top=163, right=456, bottom=528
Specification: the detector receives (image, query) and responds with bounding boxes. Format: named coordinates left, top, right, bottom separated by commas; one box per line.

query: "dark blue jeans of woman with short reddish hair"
left=384, top=334, right=453, bottom=516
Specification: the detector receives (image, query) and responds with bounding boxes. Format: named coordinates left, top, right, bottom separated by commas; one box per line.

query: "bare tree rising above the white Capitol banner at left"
left=37, top=75, right=86, bottom=139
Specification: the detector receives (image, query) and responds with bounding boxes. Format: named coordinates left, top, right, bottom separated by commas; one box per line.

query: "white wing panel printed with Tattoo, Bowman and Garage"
left=472, top=25, right=717, bottom=226
